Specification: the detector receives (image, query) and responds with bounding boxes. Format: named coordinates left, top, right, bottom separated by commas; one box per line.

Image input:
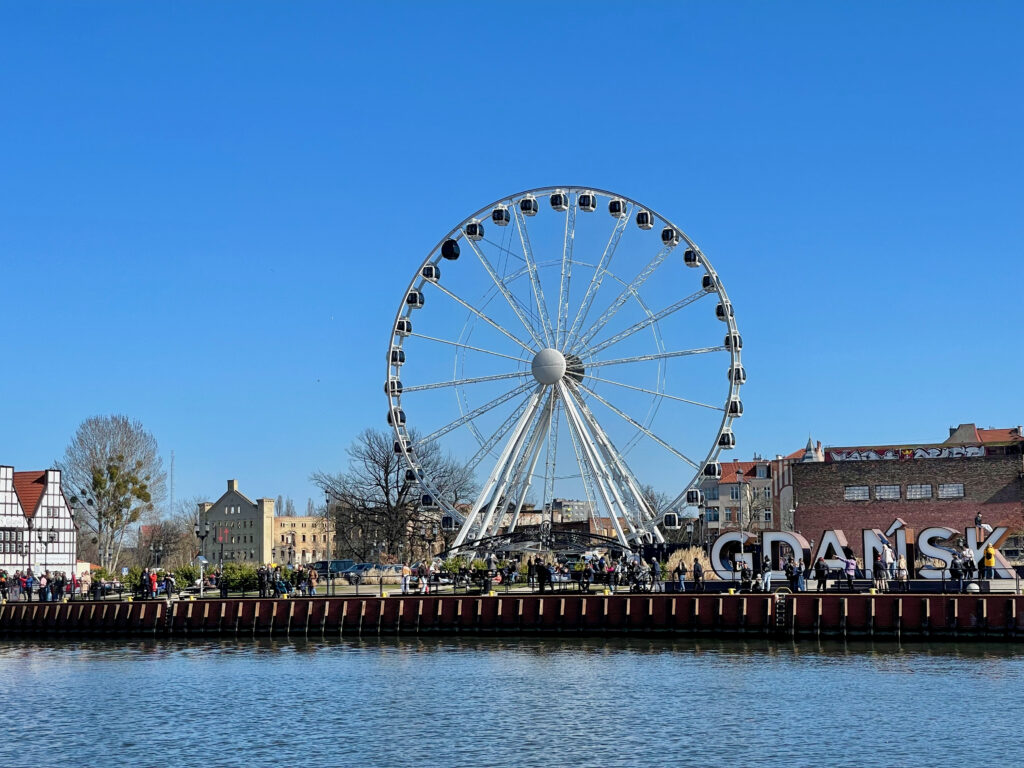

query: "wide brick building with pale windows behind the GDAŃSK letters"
left=790, top=424, right=1024, bottom=557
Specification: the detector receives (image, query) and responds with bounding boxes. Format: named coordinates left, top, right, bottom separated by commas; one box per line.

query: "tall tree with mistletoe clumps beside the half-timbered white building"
left=56, top=416, right=166, bottom=568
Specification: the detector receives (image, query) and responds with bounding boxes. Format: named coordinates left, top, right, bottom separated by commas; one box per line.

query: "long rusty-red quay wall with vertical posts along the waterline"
left=0, top=594, right=1024, bottom=641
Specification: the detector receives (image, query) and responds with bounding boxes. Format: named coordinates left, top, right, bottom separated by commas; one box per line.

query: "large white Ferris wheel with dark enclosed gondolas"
left=385, top=186, right=746, bottom=549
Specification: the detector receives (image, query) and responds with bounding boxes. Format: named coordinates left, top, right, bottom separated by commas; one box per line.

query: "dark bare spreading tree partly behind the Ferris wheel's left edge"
left=311, top=429, right=474, bottom=561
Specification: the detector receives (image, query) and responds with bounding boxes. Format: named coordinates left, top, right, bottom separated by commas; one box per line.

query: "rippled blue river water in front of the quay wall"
left=0, top=638, right=1024, bottom=768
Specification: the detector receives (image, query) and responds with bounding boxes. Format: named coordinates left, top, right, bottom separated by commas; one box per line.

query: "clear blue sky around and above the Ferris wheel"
left=0, top=2, right=1024, bottom=509
